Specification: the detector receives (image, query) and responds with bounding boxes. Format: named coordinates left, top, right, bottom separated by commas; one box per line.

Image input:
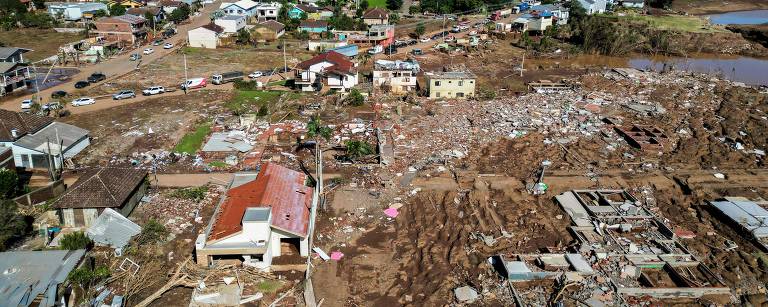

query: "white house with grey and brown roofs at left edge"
left=0, top=110, right=90, bottom=168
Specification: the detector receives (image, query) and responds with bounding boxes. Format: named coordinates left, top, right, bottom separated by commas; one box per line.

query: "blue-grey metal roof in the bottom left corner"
left=0, top=249, right=85, bottom=307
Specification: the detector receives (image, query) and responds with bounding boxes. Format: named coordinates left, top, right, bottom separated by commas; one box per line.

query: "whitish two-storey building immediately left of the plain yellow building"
left=373, top=60, right=419, bottom=94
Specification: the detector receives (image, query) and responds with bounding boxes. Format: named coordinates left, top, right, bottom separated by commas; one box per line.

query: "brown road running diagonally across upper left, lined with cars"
left=0, top=1, right=220, bottom=113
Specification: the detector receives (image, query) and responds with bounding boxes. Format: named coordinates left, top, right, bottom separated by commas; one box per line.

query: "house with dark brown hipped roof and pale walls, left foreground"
left=51, top=167, right=149, bottom=227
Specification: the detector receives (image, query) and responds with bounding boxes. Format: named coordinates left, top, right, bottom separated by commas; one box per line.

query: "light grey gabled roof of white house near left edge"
left=14, top=122, right=88, bottom=155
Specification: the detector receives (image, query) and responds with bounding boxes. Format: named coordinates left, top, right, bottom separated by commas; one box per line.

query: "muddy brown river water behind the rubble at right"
left=629, top=56, right=768, bottom=85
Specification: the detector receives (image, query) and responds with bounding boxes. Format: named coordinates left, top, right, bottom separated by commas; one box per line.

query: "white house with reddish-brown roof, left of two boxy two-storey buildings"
left=294, top=51, right=358, bottom=91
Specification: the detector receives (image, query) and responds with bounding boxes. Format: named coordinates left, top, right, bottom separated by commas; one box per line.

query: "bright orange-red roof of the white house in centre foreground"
left=208, top=163, right=313, bottom=241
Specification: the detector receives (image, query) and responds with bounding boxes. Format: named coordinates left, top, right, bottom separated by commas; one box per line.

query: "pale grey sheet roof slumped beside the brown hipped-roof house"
left=85, top=208, right=141, bottom=249
